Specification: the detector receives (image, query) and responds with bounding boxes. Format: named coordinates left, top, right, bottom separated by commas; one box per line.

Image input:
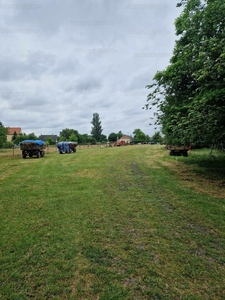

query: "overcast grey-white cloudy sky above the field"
left=0, top=0, right=182, bottom=136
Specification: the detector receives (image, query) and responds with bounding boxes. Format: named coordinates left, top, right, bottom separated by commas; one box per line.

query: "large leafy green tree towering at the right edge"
left=146, top=0, right=225, bottom=144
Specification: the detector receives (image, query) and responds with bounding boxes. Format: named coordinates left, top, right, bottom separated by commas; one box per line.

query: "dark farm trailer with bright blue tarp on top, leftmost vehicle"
left=20, top=140, right=46, bottom=158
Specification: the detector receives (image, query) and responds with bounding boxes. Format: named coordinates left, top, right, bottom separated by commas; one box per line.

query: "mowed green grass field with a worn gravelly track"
left=0, top=145, right=225, bottom=300
